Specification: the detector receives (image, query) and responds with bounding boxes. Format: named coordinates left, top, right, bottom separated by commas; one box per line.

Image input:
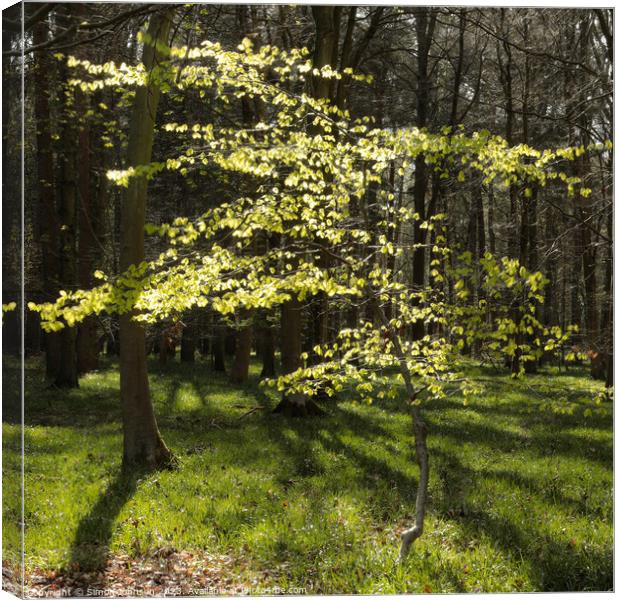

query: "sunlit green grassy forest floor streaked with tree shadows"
left=3, top=357, right=613, bottom=596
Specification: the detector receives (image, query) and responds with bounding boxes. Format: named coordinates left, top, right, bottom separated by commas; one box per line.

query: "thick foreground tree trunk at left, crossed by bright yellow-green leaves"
left=120, top=9, right=173, bottom=468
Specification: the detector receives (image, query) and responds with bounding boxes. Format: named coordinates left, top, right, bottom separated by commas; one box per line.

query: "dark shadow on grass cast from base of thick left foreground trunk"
left=71, top=470, right=144, bottom=571
